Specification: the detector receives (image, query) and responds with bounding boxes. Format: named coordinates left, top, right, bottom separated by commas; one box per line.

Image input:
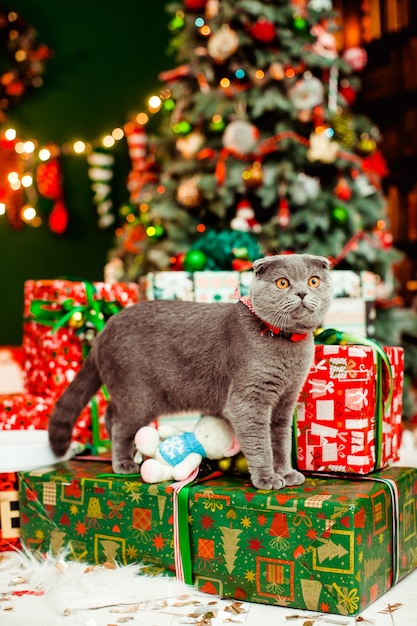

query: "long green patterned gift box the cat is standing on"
left=20, top=460, right=417, bottom=615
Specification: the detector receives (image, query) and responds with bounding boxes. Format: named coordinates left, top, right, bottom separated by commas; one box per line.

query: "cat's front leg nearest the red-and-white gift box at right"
left=271, top=393, right=305, bottom=487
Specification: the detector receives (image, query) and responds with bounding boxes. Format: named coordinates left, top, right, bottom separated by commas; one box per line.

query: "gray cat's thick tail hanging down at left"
left=48, top=349, right=102, bottom=457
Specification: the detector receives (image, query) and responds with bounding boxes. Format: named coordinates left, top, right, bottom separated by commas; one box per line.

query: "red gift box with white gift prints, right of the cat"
left=294, top=331, right=404, bottom=474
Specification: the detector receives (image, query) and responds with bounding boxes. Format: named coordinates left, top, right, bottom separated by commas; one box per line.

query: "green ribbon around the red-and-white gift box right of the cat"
left=310, top=328, right=394, bottom=469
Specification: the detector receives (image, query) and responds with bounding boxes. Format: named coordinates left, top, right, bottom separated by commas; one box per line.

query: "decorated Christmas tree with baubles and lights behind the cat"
left=110, top=0, right=416, bottom=420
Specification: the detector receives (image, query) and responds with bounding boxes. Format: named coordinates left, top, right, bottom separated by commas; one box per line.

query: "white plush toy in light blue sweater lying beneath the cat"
left=135, top=416, right=240, bottom=483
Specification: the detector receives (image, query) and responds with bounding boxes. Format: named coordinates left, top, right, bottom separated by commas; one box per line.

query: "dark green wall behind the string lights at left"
left=0, top=0, right=170, bottom=345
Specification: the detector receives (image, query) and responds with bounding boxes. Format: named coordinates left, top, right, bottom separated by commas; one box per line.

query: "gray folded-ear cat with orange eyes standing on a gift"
left=49, top=254, right=332, bottom=489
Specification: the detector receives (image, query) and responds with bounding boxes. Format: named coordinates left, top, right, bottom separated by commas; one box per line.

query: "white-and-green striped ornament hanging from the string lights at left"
left=87, top=148, right=114, bottom=228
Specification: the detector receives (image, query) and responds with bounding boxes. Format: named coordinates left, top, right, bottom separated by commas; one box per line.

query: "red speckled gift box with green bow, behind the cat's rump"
left=23, top=280, right=138, bottom=396
